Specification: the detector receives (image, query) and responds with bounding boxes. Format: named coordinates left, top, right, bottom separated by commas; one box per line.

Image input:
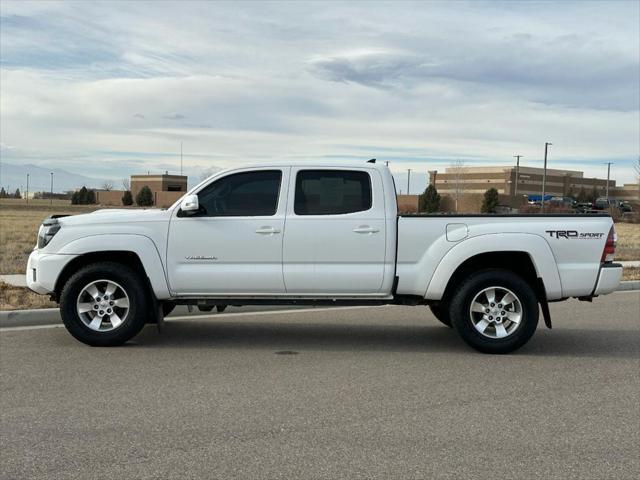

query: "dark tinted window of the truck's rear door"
left=294, top=170, right=371, bottom=215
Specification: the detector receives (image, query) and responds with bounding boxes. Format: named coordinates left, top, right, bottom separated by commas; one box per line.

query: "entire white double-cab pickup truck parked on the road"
left=26, top=162, right=622, bottom=353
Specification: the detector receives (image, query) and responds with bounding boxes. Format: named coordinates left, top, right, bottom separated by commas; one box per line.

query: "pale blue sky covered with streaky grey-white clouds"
left=0, top=0, right=640, bottom=193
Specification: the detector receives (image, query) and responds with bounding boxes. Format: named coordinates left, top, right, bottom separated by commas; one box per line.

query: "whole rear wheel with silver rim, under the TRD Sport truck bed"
left=449, top=269, right=538, bottom=353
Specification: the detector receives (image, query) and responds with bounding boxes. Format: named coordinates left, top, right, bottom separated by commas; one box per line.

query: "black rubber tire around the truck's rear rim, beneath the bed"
left=449, top=269, right=538, bottom=354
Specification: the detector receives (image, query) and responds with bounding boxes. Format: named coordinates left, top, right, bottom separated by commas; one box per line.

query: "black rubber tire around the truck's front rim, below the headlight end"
left=60, top=262, right=153, bottom=347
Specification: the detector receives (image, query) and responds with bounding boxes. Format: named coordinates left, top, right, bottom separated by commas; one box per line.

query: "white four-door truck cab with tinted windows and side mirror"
left=166, top=163, right=396, bottom=297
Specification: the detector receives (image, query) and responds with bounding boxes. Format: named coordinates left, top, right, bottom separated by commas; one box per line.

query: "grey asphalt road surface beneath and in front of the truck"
left=0, top=292, right=640, bottom=479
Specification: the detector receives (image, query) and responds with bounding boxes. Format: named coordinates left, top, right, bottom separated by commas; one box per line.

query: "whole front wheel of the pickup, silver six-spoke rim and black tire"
left=60, top=262, right=149, bottom=346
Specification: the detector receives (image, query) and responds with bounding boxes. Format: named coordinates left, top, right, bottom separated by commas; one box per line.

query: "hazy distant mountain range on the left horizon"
left=0, top=162, right=102, bottom=193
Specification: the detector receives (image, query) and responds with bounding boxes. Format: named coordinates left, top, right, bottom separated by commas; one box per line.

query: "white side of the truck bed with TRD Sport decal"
left=397, top=213, right=613, bottom=300
